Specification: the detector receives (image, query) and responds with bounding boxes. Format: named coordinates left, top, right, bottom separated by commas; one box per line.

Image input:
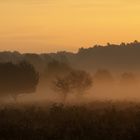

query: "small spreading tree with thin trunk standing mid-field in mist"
left=54, top=70, right=92, bottom=102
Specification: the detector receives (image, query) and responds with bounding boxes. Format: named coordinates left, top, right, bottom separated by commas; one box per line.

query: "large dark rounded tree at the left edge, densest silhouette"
left=0, top=61, right=39, bottom=99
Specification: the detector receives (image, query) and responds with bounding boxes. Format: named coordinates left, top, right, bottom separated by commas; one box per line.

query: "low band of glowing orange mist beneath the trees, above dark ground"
left=0, top=83, right=140, bottom=105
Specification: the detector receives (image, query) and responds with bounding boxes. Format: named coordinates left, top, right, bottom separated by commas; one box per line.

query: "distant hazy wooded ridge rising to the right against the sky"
left=0, top=41, right=140, bottom=73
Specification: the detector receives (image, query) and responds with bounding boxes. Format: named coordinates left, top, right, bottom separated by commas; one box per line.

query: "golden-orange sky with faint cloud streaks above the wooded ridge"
left=0, top=0, right=140, bottom=53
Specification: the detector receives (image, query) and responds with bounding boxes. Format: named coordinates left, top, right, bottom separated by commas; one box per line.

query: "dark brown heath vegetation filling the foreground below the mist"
left=0, top=103, right=140, bottom=140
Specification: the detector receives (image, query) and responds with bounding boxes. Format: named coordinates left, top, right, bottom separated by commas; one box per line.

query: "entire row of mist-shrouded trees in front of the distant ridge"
left=0, top=48, right=136, bottom=102
